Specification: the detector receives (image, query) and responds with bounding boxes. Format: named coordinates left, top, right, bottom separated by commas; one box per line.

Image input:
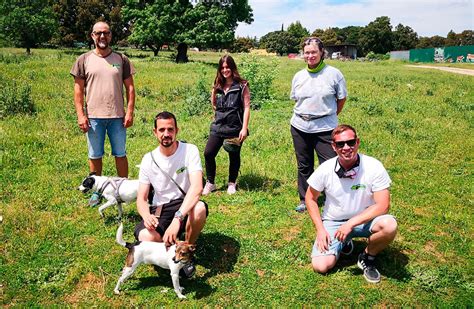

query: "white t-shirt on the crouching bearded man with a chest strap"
left=138, top=142, right=202, bottom=205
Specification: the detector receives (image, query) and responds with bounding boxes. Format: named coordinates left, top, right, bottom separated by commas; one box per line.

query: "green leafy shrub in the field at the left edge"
left=0, top=82, right=36, bottom=119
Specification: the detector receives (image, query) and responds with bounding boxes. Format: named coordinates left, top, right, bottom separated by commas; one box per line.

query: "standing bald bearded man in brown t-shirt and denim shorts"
left=71, top=22, right=135, bottom=177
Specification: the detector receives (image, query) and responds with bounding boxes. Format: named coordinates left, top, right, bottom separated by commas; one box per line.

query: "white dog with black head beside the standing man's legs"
left=78, top=173, right=138, bottom=218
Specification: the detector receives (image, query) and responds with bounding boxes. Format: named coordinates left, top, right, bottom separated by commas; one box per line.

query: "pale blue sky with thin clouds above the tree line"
left=236, top=0, right=474, bottom=38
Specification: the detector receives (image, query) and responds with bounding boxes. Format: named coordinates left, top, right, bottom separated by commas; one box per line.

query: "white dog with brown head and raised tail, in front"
left=114, top=223, right=196, bottom=299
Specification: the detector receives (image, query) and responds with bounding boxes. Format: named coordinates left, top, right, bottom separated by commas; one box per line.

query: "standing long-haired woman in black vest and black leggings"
left=202, top=55, right=250, bottom=195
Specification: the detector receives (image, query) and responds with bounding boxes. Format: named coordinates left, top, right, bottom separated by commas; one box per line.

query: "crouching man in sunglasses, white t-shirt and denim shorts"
left=305, top=125, right=397, bottom=283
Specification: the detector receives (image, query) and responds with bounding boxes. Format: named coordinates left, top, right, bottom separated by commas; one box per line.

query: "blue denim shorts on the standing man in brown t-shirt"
left=86, top=118, right=127, bottom=159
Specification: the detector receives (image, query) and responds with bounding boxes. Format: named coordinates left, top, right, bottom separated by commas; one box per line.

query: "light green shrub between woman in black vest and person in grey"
left=240, top=55, right=278, bottom=110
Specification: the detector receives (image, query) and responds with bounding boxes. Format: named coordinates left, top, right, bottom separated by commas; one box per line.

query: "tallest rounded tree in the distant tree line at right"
left=358, top=16, right=393, bottom=54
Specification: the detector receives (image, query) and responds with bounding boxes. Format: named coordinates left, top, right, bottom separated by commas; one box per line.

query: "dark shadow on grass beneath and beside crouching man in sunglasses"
left=331, top=240, right=411, bottom=282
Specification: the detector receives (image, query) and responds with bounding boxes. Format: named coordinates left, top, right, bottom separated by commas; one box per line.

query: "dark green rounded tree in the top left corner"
left=0, top=0, right=57, bottom=54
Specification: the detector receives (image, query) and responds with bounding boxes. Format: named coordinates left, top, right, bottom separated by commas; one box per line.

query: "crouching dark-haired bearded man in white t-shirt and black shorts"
left=135, top=112, right=208, bottom=278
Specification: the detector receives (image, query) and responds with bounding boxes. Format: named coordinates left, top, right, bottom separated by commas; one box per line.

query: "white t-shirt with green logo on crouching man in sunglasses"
left=308, top=154, right=392, bottom=221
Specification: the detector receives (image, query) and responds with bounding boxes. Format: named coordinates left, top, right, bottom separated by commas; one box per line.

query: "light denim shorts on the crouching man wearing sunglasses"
left=311, top=215, right=395, bottom=258
